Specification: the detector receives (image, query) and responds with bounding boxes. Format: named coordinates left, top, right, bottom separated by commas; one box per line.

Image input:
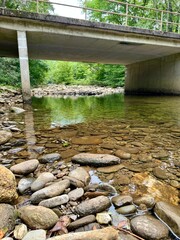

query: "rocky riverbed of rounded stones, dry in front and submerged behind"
left=0, top=88, right=180, bottom=240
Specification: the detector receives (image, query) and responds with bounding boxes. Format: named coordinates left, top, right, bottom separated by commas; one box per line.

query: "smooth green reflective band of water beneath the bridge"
left=33, top=94, right=180, bottom=127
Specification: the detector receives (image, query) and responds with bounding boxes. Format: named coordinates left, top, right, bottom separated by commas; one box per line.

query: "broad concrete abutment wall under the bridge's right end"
left=125, top=54, right=180, bottom=95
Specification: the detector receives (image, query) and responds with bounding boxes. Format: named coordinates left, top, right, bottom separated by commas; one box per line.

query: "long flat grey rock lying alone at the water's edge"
left=72, top=153, right=120, bottom=166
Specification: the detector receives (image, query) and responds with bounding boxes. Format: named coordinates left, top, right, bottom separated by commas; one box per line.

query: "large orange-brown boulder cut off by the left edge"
left=0, top=165, right=18, bottom=203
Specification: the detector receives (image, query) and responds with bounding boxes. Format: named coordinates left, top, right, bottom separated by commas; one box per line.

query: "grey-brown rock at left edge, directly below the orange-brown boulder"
left=0, top=204, right=16, bottom=231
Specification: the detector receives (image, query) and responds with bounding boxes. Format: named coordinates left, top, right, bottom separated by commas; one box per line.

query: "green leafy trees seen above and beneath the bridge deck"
left=0, top=0, right=180, bottom=87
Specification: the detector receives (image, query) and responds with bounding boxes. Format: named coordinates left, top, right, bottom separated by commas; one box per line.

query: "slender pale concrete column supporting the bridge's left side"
left=17, top=31, right=31, bottom=102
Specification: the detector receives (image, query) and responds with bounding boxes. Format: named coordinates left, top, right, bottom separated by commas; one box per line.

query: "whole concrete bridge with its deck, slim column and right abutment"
left=0, top=5, right=180, bottom=101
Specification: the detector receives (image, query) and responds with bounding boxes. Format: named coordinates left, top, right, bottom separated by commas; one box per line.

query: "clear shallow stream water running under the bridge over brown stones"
left=9, top=94, right=180, bottom=204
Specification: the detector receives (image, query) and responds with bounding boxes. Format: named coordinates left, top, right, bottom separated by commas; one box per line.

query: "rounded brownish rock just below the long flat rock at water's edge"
left=69, top=167, right=90, bottom=186
